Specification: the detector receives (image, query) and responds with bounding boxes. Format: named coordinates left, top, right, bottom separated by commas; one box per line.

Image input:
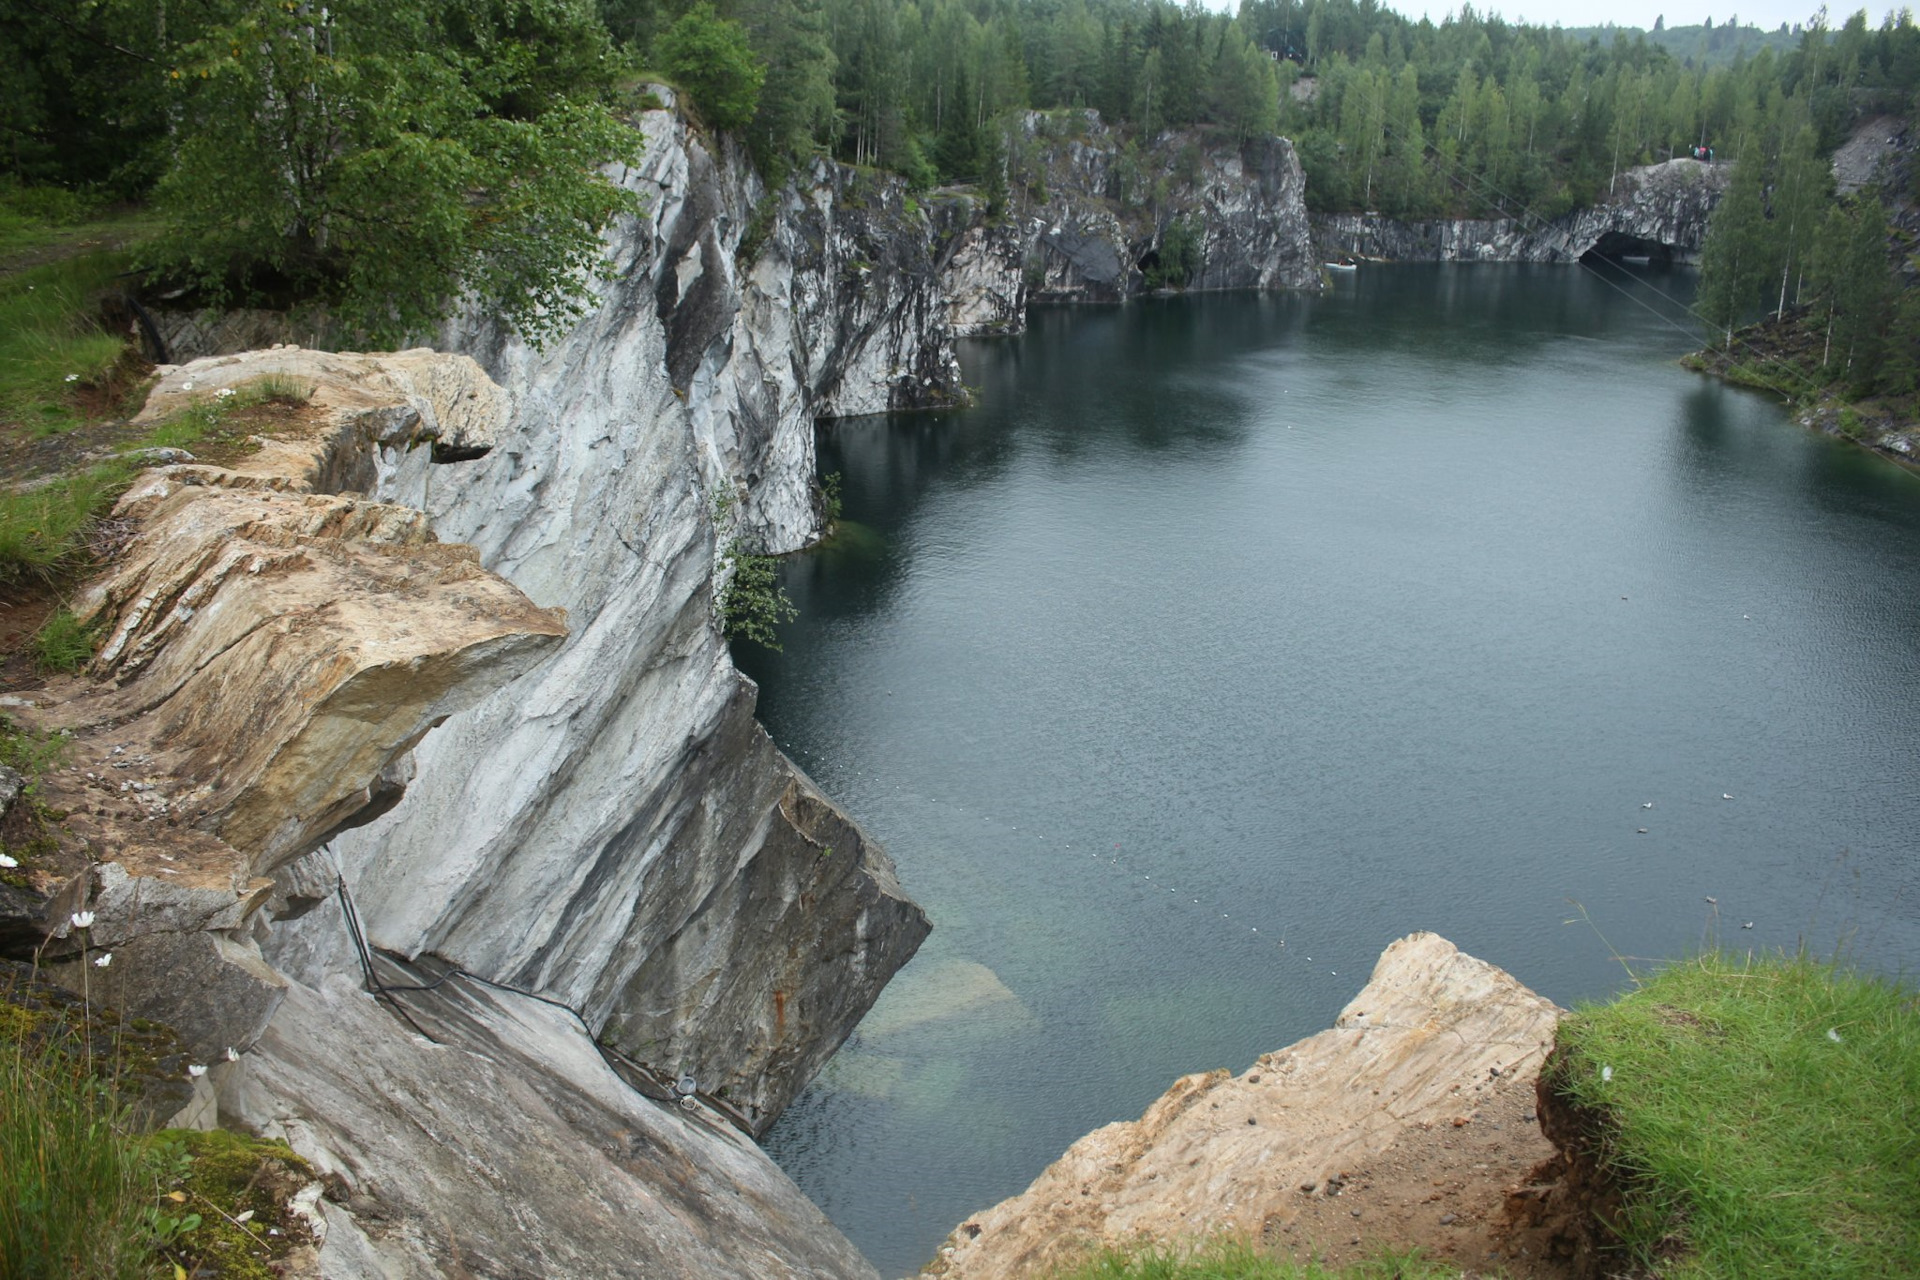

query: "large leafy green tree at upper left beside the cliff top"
left=148, top=0, right=634, bottom=342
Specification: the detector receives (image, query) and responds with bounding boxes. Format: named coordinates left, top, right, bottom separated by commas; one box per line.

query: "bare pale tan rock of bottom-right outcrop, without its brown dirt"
left=927, top=933, right=1561, bottom=1280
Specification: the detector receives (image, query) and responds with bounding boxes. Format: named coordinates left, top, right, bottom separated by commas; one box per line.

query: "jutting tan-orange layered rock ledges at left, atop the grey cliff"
left=21, top=347, right=566, bottom=1055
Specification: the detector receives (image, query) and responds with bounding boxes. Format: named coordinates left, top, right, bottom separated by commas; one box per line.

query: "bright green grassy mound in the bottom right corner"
left=1555, top=954, right=1920, bottom=1280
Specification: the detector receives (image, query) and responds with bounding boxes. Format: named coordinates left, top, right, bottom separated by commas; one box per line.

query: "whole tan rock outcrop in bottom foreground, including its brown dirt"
left=924, top=933, right=1571, bottom=1280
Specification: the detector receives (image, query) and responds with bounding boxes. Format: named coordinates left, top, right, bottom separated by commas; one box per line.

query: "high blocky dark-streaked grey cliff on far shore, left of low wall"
left=943, top=111, right=1321, bottom=334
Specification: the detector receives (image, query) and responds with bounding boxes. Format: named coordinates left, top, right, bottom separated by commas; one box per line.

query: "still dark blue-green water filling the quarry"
left=741, top=267, right=1920, bottom=1276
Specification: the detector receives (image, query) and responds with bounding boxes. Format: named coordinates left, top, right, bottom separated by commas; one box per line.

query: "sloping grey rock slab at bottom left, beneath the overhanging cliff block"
left=213, top=959, right=877, bottom=1280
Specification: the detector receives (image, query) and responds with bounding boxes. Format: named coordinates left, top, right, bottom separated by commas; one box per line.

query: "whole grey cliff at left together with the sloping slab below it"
left=45, top=97, right=960, bottom=1280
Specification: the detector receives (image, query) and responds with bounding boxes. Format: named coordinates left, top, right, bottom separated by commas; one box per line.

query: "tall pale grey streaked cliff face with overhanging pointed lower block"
left=269, top=100, right=958, bottom=1128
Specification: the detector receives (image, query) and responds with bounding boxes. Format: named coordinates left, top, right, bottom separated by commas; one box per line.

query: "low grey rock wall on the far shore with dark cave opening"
left=1313, top=159, right=1730, bottom=263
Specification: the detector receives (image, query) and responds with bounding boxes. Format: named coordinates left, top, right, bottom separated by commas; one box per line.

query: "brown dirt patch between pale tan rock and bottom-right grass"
left=1263, top=1073, right=1574, bottom=1280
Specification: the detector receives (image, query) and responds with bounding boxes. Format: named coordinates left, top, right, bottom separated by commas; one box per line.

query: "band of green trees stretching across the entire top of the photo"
left=0, top=0, right=1920, bottom=334
